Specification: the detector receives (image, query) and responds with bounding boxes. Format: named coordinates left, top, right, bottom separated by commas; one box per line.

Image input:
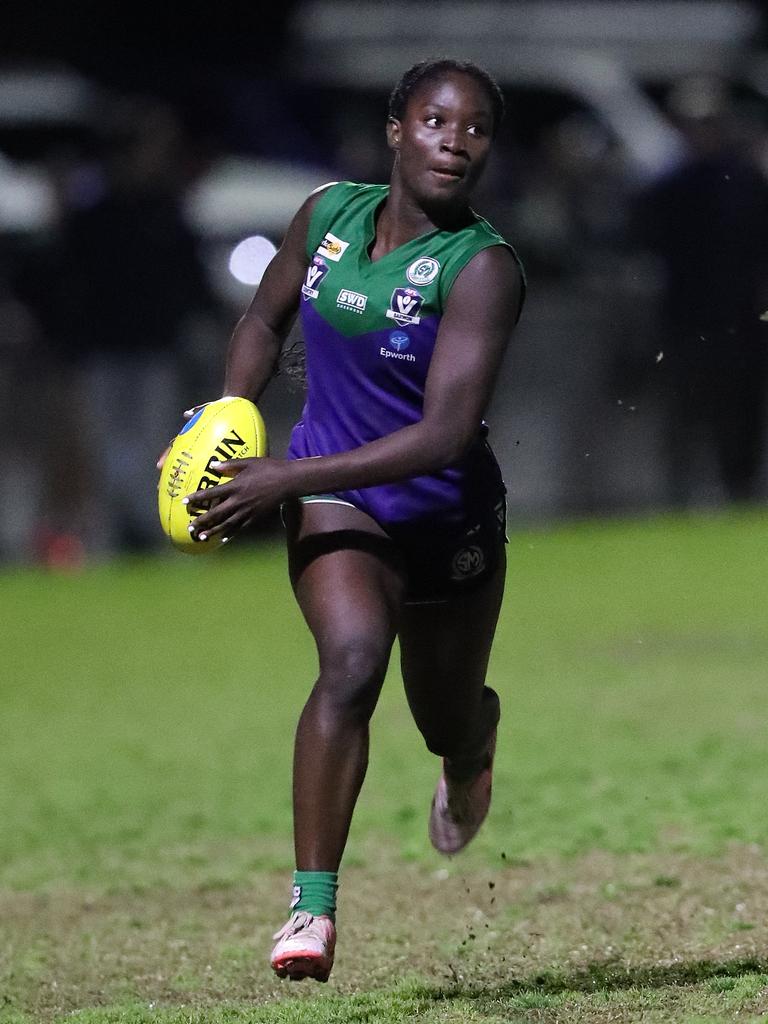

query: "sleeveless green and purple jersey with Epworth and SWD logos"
left=288, top=182, right=519, bottom=527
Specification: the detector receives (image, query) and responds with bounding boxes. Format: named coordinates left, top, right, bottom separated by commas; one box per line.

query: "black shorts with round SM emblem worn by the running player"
left=284, top=490, right=507, bottom=604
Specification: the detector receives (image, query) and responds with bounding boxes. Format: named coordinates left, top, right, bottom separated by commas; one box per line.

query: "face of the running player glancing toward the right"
left=388, top=72, right=494, bottom=204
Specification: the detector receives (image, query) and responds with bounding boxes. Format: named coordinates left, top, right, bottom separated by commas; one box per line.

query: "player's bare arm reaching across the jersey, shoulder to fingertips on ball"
left=190, top=247, right=522, bottom=534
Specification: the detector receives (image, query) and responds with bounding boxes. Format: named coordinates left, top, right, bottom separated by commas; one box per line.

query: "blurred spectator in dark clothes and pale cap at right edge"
left=639, top=79, right=768, bottom=504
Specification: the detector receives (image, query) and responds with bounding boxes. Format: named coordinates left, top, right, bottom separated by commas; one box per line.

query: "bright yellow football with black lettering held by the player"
left=158, top=398, right=267, bottom=555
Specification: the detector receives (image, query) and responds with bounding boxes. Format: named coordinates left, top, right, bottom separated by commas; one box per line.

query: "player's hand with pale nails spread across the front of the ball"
left=185, top=458, right=288, bottom=541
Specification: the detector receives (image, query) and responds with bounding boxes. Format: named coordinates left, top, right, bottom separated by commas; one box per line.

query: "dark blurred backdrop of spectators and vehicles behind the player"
left=0, top=0, right=768, bottom=566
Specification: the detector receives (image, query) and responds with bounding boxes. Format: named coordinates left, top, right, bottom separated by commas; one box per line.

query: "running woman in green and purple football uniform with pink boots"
left=183, top=60, right=524, bottom=981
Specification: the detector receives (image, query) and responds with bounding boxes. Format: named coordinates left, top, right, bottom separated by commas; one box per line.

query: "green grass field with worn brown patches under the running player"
left=0, top=511, right=768, bottom=1024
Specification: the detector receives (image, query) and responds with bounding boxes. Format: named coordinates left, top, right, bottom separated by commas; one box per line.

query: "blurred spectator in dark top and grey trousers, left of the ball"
left=17, top=100, right=219, bottom=554
